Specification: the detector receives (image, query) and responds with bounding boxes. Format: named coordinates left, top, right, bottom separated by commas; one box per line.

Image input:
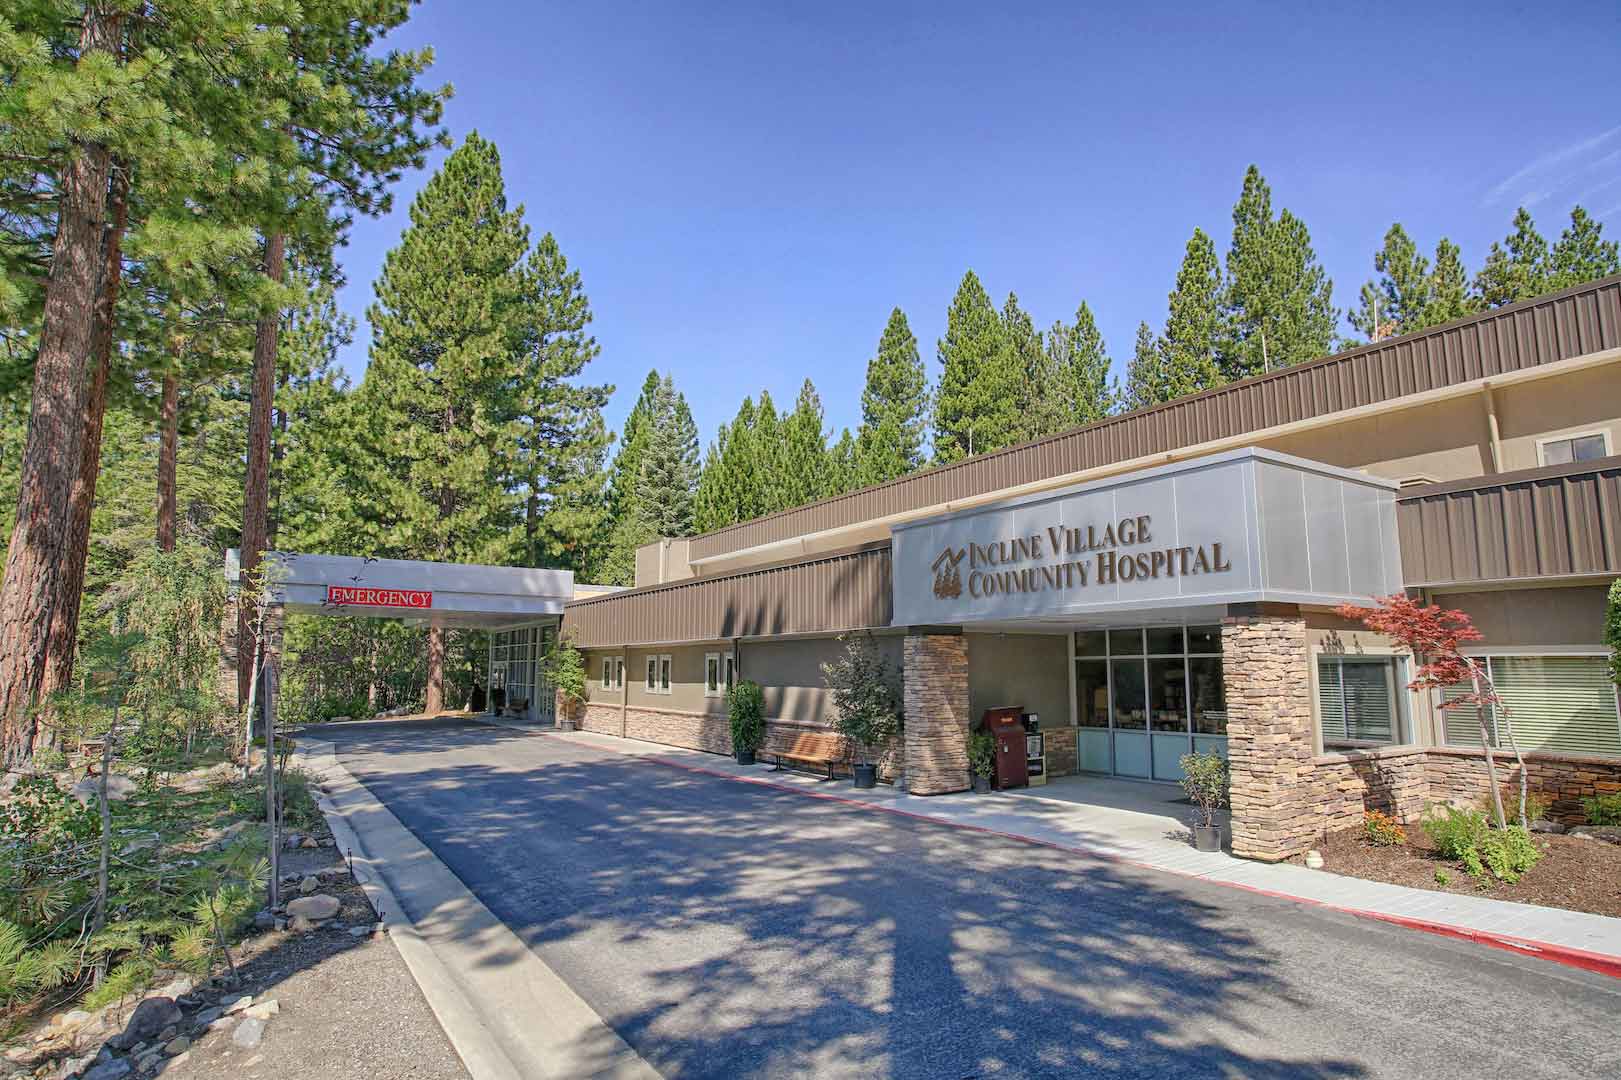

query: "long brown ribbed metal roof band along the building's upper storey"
left=691, top=276, right=1621, bottom=559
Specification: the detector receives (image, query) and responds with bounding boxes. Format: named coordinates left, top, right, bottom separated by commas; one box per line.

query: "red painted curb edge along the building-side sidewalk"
left=619, top=751, right=1621, bottom=979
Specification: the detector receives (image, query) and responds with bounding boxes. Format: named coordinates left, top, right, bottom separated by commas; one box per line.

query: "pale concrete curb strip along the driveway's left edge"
left=297, top=739, right=658, bottom=1080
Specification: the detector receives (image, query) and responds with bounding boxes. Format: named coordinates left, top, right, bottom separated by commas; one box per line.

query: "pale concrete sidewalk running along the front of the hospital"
left=486, top=720, right=1621, bottom=978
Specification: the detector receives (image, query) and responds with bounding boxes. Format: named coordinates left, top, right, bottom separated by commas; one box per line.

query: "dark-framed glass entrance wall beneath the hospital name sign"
left=1073, top=626, right=1227, bottom=780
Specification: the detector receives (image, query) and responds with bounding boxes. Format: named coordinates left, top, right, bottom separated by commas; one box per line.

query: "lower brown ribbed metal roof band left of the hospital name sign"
left=562, top=543, right=892, bottom=649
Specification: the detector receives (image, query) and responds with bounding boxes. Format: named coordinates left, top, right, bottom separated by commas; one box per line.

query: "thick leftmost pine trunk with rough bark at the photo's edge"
left=0, top=3, right=120, bottom=764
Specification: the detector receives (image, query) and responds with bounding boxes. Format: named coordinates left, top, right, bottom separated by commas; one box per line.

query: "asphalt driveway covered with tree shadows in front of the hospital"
left=313, top=720, right=1621, bottom=1080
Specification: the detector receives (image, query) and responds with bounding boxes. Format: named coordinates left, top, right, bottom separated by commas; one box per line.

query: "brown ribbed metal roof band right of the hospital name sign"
left=1396, top=457, right=1621, bottom=587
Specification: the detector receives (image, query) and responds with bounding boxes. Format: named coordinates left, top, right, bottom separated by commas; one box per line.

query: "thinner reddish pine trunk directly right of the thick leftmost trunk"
left=34, top=162, right=130, bottom=744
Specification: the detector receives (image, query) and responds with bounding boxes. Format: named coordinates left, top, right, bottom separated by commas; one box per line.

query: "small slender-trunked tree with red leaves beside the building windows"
left=1337, top=594, right=1527, bottom=829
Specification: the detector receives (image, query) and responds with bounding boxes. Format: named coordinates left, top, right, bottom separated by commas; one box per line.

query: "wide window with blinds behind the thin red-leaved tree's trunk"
left=1441, top=657, right=1621, bottom=756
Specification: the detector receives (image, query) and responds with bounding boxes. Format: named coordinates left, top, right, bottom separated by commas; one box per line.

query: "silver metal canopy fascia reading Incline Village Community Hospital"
left=893, top=449, right=1401, bottom=624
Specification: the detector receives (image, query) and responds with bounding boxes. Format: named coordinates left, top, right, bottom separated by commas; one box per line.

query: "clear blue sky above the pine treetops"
left=340, top=0, right=1621, bottom=444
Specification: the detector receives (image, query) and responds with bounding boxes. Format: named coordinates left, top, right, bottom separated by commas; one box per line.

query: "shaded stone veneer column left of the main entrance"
left=901, top=632, right=968, bottom=795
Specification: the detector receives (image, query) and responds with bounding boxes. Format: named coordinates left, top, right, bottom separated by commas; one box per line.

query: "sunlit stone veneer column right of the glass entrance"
left=1221, top=605, right=1318, bottom=863
